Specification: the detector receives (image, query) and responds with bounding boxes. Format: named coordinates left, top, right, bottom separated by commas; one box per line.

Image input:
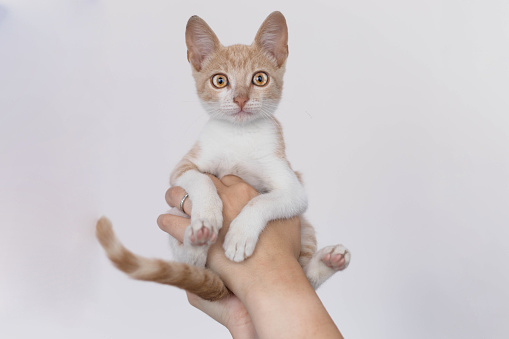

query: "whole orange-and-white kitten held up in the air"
left=97, top=12, right=350, bottom=300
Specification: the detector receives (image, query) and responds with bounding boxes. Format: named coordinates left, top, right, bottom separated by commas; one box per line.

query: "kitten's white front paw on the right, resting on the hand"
left=223, top=217, right=259, bottom=262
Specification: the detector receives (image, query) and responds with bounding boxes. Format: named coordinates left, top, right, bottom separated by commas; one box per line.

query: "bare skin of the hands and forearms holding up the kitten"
left=158, top=175, right=343, bottom=339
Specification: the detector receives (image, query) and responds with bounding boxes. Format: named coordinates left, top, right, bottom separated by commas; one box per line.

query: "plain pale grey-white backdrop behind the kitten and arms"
left=0, top=0, right=509, bottom=339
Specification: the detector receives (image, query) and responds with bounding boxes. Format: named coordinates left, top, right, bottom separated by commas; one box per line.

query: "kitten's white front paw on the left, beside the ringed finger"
left=186, top=196, right=223, bottom=245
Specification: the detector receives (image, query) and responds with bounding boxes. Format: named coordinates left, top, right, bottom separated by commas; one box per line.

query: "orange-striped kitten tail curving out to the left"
left=96, top=217, right=230, bottom=301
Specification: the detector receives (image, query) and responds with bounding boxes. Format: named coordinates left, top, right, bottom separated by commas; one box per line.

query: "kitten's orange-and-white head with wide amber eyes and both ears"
left=186, top=12, right=288, bottom=124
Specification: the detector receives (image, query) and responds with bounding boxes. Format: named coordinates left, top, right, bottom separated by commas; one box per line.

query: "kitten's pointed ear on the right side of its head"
left=255, top=12, right=288, bottom=67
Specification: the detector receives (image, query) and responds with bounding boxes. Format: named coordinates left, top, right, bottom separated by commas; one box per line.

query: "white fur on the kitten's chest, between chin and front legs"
left=196, top=119, right=285, bottom=192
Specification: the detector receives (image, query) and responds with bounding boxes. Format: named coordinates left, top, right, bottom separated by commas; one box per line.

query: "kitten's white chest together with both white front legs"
left=175, top=115, right=307, bottom=264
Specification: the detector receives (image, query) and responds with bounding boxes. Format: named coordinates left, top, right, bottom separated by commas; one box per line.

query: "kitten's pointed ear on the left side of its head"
left=186, top=15, right=221, bottom=72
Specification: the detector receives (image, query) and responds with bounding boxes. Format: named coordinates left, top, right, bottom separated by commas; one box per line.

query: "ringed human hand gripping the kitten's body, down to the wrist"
left=158, top=175, right=300, bottom=295
